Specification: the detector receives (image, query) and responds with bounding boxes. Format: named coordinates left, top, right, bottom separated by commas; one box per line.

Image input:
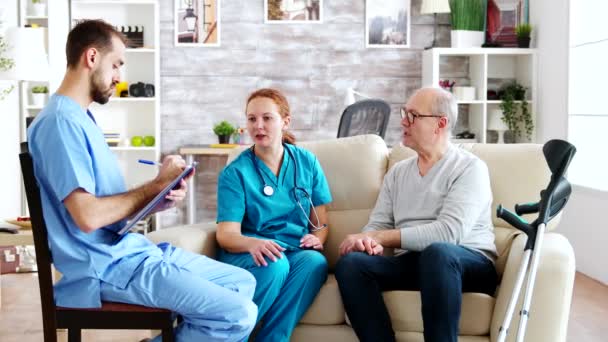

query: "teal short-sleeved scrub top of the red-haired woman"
left=217, top=144, right=332, bottom=250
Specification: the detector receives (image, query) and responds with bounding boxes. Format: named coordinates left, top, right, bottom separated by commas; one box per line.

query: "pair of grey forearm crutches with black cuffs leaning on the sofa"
left=496, top=140, right=576, bottom=342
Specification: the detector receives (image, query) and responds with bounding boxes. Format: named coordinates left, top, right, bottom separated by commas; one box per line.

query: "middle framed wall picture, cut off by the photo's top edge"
left=264, top=0, right=323, bottom=24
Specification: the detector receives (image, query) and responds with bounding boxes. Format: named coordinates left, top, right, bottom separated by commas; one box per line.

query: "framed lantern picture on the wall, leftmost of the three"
left=173, top=0, right=221, bottom=47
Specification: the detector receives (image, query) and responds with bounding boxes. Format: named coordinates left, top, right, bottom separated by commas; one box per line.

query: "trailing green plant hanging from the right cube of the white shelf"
left=498, top=81, right=534, bottom=140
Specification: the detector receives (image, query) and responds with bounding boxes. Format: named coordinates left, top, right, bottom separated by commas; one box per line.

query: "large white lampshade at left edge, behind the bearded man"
left=0, top=27, right=49, bottom=81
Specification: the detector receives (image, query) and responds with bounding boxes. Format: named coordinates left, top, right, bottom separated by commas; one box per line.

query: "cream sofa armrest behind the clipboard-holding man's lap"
left=147, top=222, right=217, bottom=258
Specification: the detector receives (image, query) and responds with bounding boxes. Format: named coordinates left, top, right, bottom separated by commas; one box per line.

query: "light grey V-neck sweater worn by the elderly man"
left=363, top=144, right=496, bottom=260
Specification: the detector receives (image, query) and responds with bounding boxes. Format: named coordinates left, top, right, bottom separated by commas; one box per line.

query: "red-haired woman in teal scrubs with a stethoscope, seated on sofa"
left=217, top=89, right=331, bottom=341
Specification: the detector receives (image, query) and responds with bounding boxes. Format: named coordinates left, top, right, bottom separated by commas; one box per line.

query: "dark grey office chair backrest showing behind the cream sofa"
left=338, top=99, right=391, bottom=139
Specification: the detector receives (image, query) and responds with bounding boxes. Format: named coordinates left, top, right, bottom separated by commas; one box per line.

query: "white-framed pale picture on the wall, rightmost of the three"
left=365, top=0, right=410, bottom=48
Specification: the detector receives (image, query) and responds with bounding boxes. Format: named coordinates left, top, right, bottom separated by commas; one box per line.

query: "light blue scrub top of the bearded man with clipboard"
left=27, top=94, right=162, bottom=307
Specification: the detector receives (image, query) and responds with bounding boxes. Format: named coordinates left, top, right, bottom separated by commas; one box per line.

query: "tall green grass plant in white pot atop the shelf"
left=449, top=0, right=487, bottom=48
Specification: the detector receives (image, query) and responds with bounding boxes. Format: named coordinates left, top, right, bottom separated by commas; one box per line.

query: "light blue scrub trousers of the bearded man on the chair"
left=101, top=246, right=257, bottom=342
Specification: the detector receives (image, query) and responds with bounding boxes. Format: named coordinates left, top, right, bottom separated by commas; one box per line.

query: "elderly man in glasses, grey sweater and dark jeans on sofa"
left=336, top=88, right=497, bottom=342
